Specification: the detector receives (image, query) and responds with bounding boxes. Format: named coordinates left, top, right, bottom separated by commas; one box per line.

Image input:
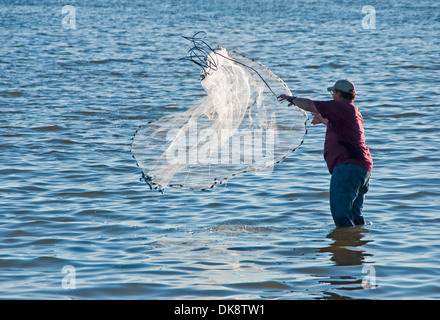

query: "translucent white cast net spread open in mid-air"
left=131, top=34, right=307, bottom=191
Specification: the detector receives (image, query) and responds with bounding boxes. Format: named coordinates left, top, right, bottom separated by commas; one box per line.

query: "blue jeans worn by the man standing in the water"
left=330, top=164, right=371, bottom=227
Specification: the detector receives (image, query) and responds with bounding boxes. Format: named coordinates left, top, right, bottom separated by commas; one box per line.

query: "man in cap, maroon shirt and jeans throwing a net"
left=279, top=80, right=373, bottom=227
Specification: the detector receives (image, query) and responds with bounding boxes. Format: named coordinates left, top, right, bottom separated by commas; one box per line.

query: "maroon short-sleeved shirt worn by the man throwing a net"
left=313, top=100, right=373, bottom=173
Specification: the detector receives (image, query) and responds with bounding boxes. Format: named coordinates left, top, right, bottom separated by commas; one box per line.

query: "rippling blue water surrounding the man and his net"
left=0, top=0, right=440, bottom=299
